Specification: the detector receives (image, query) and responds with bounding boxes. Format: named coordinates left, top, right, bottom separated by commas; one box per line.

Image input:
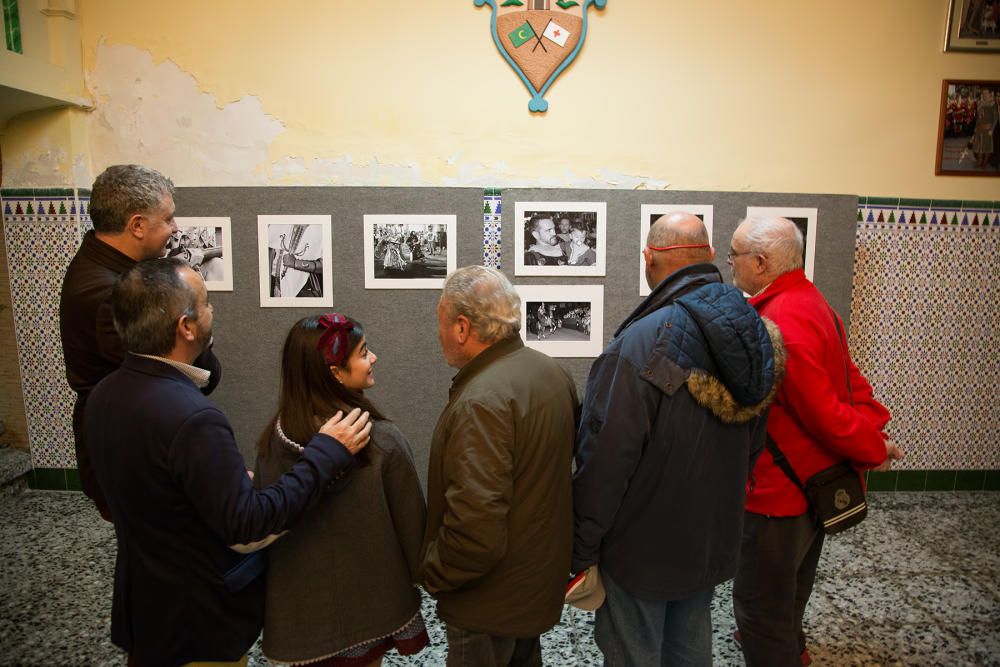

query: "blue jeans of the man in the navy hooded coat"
left=594, top=571, right=715, bottom=667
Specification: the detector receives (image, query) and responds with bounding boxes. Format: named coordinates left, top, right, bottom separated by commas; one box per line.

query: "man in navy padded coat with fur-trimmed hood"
left=572, top=212, right=783, bottom=665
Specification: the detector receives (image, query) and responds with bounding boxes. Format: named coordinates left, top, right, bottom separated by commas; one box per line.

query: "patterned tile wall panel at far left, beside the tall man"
left=0, top=190, right=80, bottom=468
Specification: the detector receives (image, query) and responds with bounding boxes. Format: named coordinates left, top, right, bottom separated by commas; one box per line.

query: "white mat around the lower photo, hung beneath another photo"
left=515, top=285, right=604, bottom=357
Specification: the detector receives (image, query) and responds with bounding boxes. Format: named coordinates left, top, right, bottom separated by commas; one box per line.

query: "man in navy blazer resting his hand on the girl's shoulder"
left=84, top=259, right=371, bottom=667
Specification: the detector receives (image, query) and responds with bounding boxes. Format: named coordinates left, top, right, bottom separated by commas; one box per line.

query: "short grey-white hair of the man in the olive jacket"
left=441, top=266, right=521, bottom=344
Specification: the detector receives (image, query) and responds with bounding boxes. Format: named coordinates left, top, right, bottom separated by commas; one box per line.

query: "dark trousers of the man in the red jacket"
left=733, top=512, right=824, bottom=667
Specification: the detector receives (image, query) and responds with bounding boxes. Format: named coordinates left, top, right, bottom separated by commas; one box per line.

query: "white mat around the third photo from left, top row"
left=363, top=214, right=458, bottom=289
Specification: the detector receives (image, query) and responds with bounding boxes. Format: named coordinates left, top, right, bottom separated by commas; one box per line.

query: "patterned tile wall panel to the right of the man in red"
left=850, top=198, right=1000, bottom=470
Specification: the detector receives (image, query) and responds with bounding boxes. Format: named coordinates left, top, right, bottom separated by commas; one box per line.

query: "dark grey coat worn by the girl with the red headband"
left=254, top=420, right=425, bottom=662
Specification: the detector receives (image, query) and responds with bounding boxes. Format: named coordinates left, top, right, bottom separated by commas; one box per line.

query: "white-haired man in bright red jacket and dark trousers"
left=729, top=218, right=902, bottom=667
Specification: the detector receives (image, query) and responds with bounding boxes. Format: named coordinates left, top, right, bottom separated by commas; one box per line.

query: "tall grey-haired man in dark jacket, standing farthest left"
left=59, top=164, right=222, bottom=520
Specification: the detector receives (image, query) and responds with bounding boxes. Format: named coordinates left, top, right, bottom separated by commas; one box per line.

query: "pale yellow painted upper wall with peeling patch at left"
left=5, top=0, right=1000, bottom=199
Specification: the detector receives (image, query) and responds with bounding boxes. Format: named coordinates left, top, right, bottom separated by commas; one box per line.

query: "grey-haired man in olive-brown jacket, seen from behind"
left=423, top=266, right=577, bottom=667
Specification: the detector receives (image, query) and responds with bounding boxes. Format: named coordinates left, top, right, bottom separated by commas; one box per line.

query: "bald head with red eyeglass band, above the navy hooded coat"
left=643, top=211, right=715, bottom=289
